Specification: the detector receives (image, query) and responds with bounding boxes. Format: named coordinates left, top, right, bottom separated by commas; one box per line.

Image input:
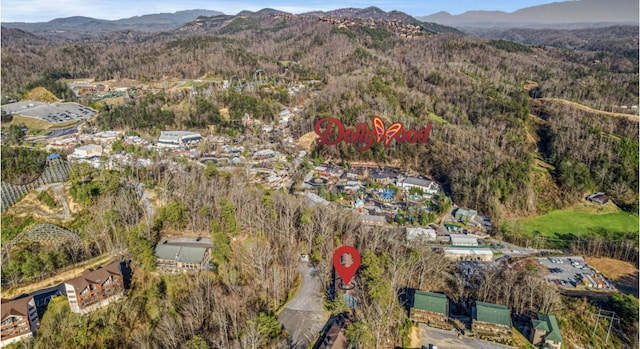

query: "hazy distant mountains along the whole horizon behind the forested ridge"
left=2, top=0, right=639, bottom=36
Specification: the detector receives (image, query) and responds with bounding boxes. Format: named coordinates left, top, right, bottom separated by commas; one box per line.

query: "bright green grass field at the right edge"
left=517, top=208, right=638, bottom=237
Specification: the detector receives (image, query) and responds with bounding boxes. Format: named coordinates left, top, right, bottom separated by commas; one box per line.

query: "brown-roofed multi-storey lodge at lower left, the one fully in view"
left=64, top=261, right=124, bottom=314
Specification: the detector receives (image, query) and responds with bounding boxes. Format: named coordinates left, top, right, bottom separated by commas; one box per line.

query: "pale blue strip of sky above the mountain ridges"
left=0, top=0, right=553, bottom=22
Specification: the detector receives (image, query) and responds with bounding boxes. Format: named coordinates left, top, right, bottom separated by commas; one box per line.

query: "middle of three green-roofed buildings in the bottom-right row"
left=471, top=301, right=511, bottom=337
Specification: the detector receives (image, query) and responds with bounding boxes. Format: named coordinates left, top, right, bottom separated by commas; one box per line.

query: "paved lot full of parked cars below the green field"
left=538, top=256, right=613, bottom=290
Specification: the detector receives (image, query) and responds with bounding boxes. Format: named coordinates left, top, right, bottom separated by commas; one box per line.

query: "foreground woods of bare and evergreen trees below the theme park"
left=2, top=160, right=637, bottom=349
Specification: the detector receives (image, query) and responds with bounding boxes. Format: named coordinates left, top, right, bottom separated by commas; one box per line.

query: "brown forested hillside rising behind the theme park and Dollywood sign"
left=2, top=11, right=638, bottom=218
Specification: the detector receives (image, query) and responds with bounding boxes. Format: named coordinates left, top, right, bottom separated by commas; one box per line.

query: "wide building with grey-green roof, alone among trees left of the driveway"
left=155, top=241, right=211, bottom=274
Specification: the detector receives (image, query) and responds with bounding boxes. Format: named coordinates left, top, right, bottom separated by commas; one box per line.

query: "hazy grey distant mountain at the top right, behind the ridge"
left=416, top=0, right=639, bottom=28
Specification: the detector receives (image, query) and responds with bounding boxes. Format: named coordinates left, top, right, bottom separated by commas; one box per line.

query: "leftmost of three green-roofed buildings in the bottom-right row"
left=409, top=290, right=451, bottom=329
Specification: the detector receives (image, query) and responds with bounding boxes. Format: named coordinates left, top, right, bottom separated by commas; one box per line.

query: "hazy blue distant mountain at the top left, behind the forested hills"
left=2, top=10, right=223, bottom=34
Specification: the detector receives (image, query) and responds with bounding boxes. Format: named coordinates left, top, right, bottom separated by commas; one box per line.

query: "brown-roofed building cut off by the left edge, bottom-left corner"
left=0, top=296, right=40, bottom=347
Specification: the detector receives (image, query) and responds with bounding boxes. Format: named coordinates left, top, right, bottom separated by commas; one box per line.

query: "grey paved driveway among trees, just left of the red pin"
left=278, top=263, right=329, bottom=349
